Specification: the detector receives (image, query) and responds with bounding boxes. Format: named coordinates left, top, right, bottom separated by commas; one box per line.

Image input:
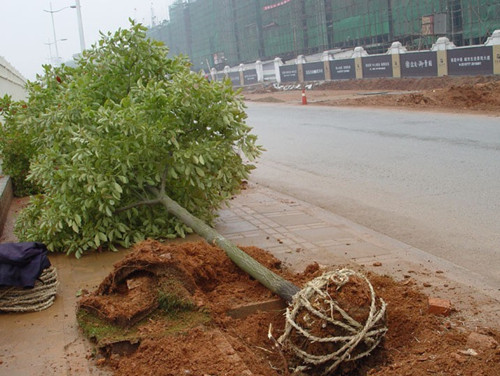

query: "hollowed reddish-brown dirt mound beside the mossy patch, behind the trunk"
left=79, top=241, right=281, bottom=327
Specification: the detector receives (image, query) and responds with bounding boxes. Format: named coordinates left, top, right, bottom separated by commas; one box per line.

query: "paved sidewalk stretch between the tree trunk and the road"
left=217, top=184, right=500, bottom=327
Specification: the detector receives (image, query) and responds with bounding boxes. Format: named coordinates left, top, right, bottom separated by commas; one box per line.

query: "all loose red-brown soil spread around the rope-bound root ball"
left=79, top=241, right=500, bottom=376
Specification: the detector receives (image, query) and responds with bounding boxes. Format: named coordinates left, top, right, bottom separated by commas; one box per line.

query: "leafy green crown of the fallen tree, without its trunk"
left=10, top=23, right=261, bottom=257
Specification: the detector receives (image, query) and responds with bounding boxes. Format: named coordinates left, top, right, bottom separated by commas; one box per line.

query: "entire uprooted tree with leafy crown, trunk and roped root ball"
left=0, top=24, right=386, bottom=374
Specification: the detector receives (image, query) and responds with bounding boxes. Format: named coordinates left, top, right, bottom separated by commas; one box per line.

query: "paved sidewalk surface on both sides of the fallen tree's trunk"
left=0, top=183, right=500, bottom=376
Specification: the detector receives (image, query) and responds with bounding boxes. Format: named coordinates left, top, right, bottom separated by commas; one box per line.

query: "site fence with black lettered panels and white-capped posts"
left=210, top=30, right=500, bottom=86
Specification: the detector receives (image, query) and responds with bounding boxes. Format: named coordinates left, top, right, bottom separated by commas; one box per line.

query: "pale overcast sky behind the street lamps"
left=0, top=0, right=174, bottom=80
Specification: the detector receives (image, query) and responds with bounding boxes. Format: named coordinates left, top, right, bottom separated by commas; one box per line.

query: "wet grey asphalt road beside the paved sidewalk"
left=247, top=103, right=500, bottom=290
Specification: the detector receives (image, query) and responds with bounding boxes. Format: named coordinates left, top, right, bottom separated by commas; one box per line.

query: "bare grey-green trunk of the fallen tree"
left=158, top=194, right=300, bottom=302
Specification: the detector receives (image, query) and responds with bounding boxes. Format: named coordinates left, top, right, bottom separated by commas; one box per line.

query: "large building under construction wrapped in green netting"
left=149, top=0, right=500, bottom=71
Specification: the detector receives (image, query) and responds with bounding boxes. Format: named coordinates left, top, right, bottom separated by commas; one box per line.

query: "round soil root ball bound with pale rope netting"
left=278, top=269, right=387, bottom=375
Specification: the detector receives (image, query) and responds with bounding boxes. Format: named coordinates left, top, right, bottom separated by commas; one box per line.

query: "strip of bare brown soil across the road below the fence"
left=243, top=76, right=500, bottom=114
